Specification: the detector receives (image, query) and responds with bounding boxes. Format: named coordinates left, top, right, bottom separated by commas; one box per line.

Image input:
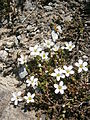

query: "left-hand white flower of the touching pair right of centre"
left=51, top=69, right=65, bottom=81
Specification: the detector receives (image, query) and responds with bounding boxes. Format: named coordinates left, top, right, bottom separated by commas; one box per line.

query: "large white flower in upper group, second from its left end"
left=29, top=45, right=42, bottom=57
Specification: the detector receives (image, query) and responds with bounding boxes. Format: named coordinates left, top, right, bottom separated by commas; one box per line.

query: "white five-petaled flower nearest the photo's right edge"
left=75, top=59, right=88, bottom=73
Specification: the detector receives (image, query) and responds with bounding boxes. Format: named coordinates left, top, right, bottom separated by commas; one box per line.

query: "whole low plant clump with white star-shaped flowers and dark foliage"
left=11, top=25, right=88, bottom=120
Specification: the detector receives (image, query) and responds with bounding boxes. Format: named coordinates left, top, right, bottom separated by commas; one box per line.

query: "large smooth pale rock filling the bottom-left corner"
left=0, top=76, right=37, bottom=120
